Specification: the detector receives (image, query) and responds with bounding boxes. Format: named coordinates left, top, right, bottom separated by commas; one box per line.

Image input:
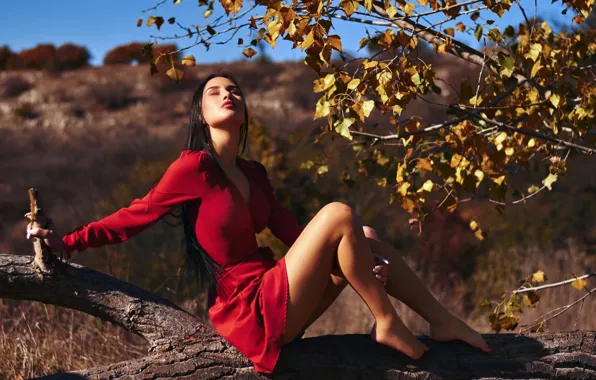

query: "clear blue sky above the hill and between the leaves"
left=0, top=0, right=571, bottom=65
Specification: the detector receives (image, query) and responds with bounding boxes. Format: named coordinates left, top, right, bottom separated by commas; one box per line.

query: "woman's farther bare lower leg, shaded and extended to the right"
left=364, top=227, right=490, bottom=352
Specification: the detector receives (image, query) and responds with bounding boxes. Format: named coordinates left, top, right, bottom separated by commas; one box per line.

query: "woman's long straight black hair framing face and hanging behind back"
left=180, top=72, right=248, bottom=291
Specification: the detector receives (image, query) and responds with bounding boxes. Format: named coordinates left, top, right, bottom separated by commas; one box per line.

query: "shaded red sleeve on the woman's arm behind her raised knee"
left=254, top=161, right=304, bottom=247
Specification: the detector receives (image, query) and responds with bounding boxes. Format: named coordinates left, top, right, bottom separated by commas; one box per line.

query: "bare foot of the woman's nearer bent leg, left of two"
left=370, top=319, right=429, bottom=360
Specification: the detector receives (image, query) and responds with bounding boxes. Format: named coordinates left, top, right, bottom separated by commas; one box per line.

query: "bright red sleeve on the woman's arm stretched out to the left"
left=62, top=151, right=207, bottom=252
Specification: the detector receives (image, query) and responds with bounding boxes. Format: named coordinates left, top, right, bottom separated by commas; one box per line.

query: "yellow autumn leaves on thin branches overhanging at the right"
left=139, top=0, right=596, bottom=331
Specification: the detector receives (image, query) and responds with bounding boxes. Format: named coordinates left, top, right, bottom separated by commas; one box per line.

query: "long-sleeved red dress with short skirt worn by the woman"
left=63, top=150, right=302, bottom=373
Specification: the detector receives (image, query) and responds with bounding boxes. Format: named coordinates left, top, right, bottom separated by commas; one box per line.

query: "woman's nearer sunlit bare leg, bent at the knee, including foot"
left=284, top=202, right=427, bottom=359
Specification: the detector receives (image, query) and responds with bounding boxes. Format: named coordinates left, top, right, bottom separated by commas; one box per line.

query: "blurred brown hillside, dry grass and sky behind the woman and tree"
left=0, top=1, right=596, bottom=379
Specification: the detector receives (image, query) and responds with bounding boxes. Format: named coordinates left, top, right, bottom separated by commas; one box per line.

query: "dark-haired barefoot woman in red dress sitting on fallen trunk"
left=28, top=74, right=490, bottom=373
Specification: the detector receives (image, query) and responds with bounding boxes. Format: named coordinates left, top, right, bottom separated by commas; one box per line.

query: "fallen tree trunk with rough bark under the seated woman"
left=0, top=254, right=596, bottom=379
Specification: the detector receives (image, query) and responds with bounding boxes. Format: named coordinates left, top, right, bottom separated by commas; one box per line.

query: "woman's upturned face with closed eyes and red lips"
left=201, top=77, right=246, bottom=131
